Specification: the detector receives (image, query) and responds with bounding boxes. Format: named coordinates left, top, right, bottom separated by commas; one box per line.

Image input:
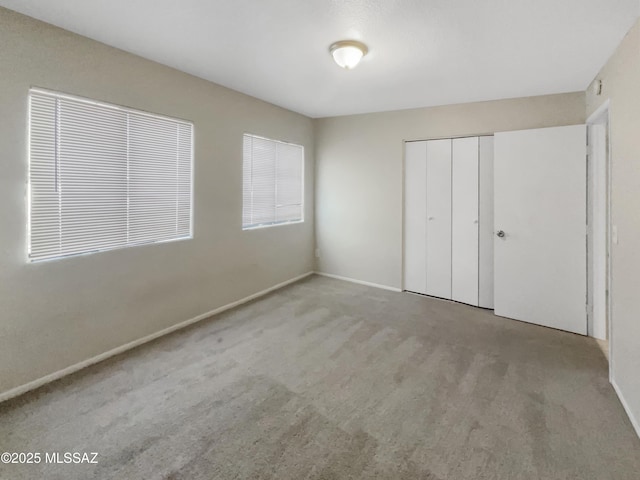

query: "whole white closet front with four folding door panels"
left=404, top=136, right=493, bottom=308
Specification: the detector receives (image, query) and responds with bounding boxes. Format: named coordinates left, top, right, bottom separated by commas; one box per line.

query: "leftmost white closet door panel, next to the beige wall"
left=404, top=142, right=427, bottom=293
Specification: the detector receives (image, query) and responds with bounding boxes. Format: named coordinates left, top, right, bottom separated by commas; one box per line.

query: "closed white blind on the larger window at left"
left=29, top=89, right=193, bottom=260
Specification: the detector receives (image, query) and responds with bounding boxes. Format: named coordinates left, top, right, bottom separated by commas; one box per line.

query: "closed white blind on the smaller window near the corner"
left=242, top=134, right=304, bottom=229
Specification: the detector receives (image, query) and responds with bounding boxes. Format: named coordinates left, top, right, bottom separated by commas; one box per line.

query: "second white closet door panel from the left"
left=427, top=139, right=451, bottom=299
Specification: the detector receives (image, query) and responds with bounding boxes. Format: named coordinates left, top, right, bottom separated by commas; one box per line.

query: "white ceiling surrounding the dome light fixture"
left=0, top=0, right=638, bottom=117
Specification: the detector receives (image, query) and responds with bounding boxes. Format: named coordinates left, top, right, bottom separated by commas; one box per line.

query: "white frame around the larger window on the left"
left=25, top=86, right=195, bottom=264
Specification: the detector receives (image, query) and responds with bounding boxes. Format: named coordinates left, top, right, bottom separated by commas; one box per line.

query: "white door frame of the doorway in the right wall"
left=587, top=99, right=613, bottom=372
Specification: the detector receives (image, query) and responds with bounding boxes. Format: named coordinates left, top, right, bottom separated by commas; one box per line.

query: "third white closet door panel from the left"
left=451, top=137, right=479, bottom=305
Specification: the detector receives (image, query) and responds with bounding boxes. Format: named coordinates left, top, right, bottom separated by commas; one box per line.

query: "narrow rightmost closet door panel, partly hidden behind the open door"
left=478, top=137, right=494, bottom=308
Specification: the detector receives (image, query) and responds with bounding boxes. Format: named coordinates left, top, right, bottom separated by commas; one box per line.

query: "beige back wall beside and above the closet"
left=316, top=93, right=585, bottom=288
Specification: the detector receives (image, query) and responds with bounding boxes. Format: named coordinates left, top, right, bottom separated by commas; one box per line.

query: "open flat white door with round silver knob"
left=494, top=125, right=587, bottom=335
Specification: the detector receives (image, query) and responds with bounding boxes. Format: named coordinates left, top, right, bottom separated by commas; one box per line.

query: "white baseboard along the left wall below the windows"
left=0, top=272, right=314, bottom=403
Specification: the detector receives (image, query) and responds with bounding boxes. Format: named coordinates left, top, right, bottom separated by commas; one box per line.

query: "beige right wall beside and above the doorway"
left=587, top=17, right=640, bottom=434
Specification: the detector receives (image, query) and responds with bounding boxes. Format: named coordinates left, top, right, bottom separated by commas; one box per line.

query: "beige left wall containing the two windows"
left=0, top=8, right=314, bottom=392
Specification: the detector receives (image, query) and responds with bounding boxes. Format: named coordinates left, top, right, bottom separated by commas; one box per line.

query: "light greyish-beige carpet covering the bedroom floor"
left=0, top=276, right=640, bottom=480
